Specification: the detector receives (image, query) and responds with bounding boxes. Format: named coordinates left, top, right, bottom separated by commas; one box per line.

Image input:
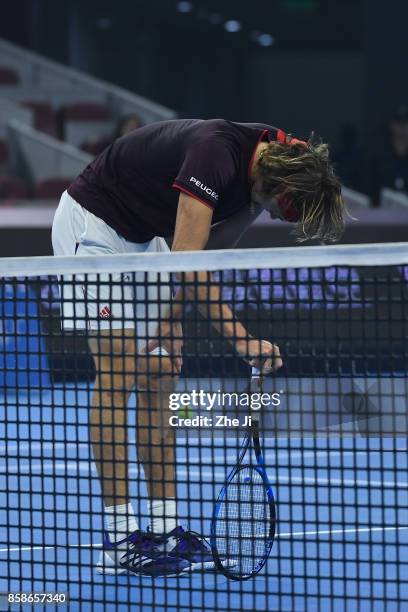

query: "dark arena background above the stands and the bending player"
left=0, top=0, right=408, bottom=147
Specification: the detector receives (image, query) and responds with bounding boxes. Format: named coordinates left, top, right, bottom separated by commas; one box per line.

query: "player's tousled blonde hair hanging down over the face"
left=255, top=135, right=346, bottom=242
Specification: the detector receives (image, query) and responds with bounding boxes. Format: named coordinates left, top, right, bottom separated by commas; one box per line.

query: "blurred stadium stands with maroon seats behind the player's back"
left=0, top=39, right=175, bottom=203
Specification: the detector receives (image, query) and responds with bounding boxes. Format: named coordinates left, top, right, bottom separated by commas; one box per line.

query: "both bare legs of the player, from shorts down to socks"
left=89, top=329, right=175, bottom=532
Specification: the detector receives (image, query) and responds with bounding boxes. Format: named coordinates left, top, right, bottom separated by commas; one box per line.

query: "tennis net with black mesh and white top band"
left=0, top=243, right=408, bottom=612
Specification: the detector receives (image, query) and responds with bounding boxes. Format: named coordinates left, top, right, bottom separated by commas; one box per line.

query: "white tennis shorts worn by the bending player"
left=52, top=191, right=171, bottom=346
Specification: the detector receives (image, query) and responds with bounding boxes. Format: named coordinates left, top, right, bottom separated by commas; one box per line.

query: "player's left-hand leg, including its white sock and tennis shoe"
left=90, top=329, right=190, bottom=576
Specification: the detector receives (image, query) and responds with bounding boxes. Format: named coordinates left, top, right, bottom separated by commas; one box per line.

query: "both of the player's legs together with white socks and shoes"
left=90, top=330, right=214, bottom=575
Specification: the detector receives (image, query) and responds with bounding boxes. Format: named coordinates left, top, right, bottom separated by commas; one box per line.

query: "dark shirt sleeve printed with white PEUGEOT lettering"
left=173, top=140, right=237, bottom=208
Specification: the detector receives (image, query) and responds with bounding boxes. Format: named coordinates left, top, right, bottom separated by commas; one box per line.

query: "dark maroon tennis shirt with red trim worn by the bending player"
left=68, top=119, right=277, bottom=242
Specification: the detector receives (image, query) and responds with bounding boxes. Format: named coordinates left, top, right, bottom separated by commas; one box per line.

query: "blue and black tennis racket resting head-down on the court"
left=211, top=368, right=276, bottom=580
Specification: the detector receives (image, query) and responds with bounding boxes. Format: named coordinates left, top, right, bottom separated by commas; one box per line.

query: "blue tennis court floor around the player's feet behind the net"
left=0, top=385, right=408, bottom=612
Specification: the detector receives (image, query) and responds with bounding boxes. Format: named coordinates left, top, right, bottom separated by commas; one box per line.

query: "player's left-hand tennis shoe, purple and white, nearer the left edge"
left=96, top=531, right=190, bottom=577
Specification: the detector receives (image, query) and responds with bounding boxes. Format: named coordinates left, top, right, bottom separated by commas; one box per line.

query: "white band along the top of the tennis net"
left=0, top=242, right=408, bottom=277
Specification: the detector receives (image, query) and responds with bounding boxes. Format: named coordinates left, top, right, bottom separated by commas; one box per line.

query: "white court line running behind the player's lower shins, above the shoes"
left=0, top=461, right=408, bottom=490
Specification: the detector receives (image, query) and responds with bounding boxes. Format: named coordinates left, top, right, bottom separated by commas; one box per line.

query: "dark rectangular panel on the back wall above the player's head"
left=243, top=51, right=364, bottom=142
